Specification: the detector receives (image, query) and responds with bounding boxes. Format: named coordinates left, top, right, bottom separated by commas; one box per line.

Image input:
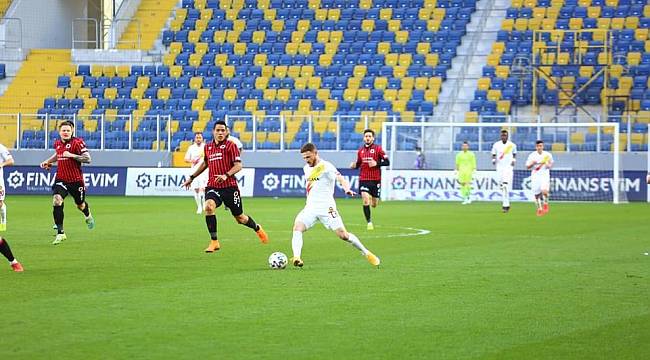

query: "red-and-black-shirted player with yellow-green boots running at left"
left=41, top=121, right=95, bottom=245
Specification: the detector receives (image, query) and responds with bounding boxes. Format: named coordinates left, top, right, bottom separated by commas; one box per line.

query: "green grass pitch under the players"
left=0, top=195, right=650, bottom=359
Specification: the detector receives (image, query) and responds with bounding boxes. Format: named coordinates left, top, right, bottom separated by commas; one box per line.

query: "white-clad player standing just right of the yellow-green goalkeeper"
left=492, top=130, right=517, bottom=213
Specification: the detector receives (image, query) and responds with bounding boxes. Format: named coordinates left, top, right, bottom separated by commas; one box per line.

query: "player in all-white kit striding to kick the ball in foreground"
left=291, top=143, right=380, bottom=267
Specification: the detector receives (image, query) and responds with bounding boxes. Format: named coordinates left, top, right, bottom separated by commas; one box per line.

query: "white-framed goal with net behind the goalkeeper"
left=382, top=122, right=628, bottom=203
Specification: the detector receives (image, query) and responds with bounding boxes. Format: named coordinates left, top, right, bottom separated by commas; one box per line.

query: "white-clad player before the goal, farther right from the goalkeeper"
left=526, top=140, right=553, bottom=216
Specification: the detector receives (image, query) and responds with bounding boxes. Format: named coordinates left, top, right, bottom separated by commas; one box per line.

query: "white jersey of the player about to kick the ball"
left=303, top=160, right=339, bottom=209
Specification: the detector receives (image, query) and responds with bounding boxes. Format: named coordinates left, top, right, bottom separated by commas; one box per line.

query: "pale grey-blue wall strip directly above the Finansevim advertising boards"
left=7, top=150, right=648, bottom=171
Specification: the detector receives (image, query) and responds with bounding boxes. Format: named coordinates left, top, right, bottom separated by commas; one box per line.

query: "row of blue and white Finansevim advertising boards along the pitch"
left=4, top=166, right=649, bottom=201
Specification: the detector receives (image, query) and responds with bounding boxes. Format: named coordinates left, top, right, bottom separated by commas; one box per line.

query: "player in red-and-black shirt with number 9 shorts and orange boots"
left=183, top=120, right=269, bottom=253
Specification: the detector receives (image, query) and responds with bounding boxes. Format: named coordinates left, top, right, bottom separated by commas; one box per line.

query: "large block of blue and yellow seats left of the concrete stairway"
left=22, top=0, right=475, bottom=149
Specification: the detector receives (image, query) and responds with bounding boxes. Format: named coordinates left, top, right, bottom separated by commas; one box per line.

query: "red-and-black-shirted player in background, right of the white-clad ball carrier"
left=350, top=129, right=390, bottom=230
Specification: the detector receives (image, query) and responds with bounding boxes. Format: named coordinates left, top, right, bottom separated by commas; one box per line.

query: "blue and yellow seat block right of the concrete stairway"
left=466, top=0, right=650, bottom=151
